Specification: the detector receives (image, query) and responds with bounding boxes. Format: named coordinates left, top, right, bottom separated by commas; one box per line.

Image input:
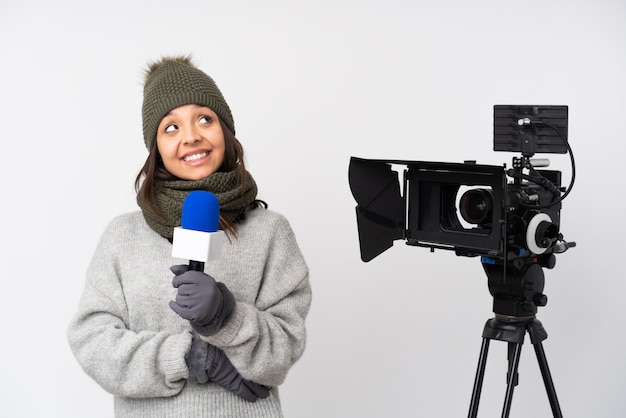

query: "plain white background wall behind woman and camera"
left=0, top=0, right=626, bottom=418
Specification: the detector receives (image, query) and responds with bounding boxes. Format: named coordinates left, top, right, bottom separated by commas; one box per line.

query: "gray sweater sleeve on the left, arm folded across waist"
left=67, top=219, right=191, bottom=398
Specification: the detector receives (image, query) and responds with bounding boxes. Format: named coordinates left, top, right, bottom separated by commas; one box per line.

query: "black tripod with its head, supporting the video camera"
left=468, top=264, right=563, bottom=418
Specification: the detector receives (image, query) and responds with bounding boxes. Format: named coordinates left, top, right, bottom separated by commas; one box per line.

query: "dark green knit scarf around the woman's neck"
left=137, top=169, right=257, bottom=239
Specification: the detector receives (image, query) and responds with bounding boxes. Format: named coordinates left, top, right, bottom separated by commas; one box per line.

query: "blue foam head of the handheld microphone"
left=181, top=190, right=220, bottom=232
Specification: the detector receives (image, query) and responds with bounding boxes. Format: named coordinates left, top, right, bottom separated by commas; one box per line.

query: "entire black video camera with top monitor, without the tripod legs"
left=349, top=105, right=575, bottom=315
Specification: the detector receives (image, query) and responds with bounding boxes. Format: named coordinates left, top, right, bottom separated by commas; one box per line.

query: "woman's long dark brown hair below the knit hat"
left=135, top=117, right=267, bottom=237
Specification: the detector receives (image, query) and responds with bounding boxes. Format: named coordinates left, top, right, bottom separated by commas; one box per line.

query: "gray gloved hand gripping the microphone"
left=170, top=264, right=235, bottom=336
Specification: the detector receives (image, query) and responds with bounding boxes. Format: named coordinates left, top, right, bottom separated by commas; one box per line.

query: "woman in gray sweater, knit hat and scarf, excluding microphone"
left=68, top=57, right=311, bottom=418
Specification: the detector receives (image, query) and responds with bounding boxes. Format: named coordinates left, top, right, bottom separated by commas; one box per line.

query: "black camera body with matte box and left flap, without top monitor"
left=350, top=157, right=561, bottom=261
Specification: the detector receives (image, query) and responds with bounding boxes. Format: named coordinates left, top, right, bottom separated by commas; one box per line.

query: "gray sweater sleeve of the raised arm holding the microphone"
left=204, top=216, right=312, bottom=386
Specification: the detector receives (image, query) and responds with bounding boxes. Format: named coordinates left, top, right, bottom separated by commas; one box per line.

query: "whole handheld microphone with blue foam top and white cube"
left=172, top=190, right=224, bottom=271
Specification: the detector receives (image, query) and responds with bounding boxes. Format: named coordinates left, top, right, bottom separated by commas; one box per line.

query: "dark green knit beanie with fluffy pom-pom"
left=141, top=57, right=235, bottom=151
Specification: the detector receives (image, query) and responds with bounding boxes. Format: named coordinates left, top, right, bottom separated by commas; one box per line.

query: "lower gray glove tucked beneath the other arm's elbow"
left=186, top=334, right=270, bottom=402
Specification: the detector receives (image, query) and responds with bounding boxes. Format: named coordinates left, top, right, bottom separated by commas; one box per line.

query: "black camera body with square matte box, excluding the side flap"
left=405, top=157, right=561, bottom=259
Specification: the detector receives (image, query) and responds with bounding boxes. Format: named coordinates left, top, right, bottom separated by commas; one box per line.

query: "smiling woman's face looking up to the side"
left=156, top=104, right=226, bottom=180
